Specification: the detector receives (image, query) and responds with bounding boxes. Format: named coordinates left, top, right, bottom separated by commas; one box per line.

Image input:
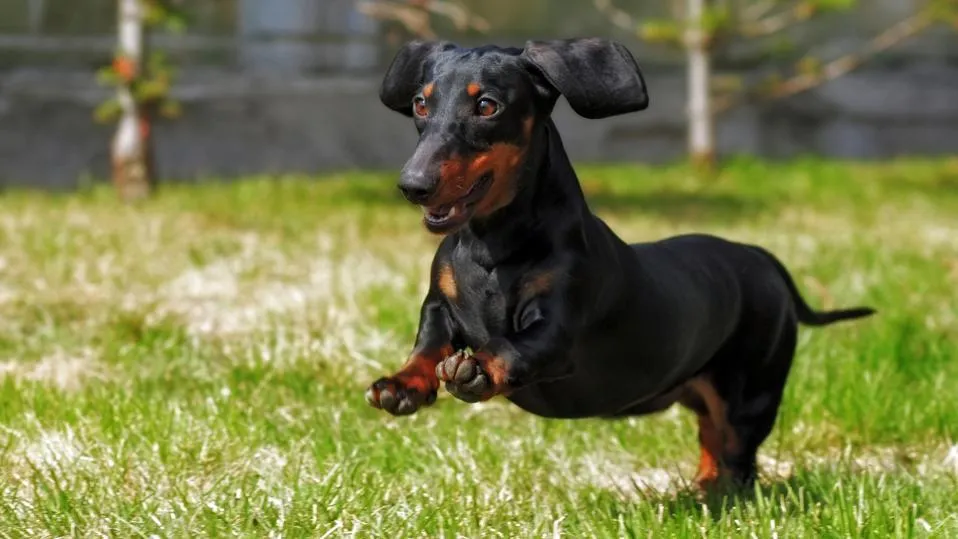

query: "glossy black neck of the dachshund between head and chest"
left=456, top=118, right=589, bottom=265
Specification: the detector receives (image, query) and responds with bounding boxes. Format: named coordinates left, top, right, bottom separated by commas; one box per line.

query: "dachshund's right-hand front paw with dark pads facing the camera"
left=436, top=352, right=506, bottom=403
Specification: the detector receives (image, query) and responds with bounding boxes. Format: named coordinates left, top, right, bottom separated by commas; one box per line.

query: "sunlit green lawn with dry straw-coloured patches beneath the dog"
left=0, top=160, right=958, bottom=538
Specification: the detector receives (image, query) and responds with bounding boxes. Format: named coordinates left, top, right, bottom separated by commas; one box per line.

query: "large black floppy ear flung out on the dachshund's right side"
left=522, top=38, right=649, bottom=119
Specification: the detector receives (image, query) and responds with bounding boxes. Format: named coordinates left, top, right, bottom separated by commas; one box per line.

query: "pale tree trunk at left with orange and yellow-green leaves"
left=112, top=0, right=153, bottom=202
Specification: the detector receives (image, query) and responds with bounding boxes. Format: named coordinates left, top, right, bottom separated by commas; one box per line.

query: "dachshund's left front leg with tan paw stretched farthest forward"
left=366, top=291, right=455, bottom=415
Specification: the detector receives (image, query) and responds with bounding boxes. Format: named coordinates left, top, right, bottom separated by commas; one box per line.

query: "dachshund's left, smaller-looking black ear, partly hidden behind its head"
left=379, top=40, right=455, bottom=117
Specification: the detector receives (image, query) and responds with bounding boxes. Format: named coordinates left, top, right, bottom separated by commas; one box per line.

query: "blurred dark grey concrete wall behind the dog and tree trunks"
left=0, top=57, right=958, bottom=188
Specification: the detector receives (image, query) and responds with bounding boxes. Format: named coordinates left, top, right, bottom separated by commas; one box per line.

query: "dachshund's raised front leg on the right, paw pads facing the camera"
left=436, top=297, right=571, bottom=403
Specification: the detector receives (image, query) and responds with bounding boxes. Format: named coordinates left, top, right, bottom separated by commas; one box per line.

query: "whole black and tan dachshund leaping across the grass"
left=366, top=39, right=874, bottom=487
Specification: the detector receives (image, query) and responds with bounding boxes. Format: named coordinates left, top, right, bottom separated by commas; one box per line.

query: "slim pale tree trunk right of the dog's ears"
left=685, top=0, right=715, bottom=169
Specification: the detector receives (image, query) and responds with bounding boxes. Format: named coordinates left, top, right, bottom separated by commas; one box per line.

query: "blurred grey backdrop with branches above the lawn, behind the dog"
left=0, top=0, right=958, bottom=194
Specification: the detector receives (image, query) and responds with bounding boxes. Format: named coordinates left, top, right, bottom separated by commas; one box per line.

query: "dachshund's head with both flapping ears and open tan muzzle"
left=380, top=38, right=649, bottom=233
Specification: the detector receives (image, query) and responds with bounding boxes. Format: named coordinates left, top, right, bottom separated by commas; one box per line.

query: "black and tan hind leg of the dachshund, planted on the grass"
left=680, top=316, right=797, bottom=489
